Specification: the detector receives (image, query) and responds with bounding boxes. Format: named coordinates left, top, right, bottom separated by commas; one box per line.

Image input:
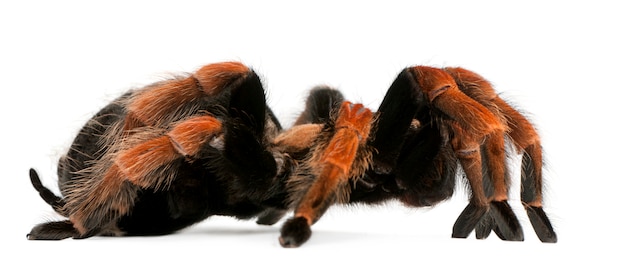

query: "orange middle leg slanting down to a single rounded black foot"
left=279, top=102, right=373, bottom=247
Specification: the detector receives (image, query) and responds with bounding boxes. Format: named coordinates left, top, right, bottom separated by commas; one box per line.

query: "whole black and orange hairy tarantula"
left=28, top=62, right=556, bottom=247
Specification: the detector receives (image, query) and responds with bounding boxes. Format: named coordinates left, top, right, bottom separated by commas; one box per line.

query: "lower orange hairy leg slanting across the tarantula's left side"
left=70, top=116, right=222, bottom=234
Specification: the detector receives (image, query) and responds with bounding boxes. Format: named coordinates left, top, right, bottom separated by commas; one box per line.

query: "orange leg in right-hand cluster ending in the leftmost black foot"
left=404, top=66, right=505, bottom=238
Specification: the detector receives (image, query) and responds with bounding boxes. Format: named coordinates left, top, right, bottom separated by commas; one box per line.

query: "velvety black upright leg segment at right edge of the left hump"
left=216, top=69, right=282, bottom=200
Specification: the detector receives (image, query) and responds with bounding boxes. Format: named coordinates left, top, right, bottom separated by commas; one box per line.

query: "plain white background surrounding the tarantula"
left=0, top=0, right=626, bottom=269
